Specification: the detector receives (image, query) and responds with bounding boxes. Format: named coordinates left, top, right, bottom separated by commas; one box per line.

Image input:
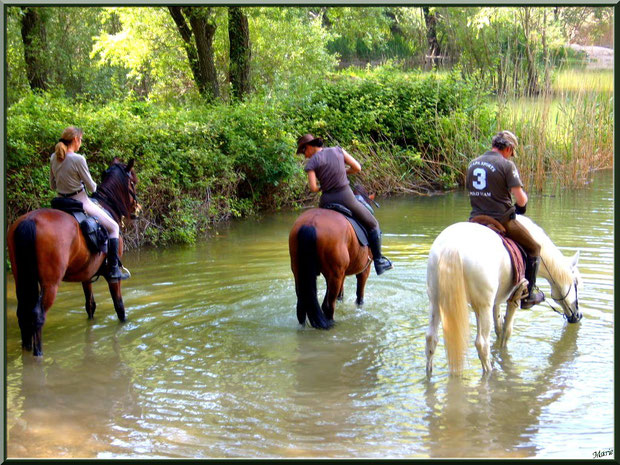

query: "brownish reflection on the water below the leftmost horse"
left=7, top=325, right=140, bottom=458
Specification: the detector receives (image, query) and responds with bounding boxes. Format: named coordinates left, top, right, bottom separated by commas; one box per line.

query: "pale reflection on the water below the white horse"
left=425, top=325, right=579, bottom=458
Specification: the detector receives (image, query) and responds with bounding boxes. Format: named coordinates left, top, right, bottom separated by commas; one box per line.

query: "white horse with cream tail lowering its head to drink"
left=426, top=215, right=582, bottom=377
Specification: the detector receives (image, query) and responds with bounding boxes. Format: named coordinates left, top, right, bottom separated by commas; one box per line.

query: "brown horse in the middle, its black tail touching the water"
left=288, top=208, right=372, bottom=329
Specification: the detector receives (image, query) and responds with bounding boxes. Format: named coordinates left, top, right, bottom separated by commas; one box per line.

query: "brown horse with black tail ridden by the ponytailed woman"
left=7, top=158, right=141, bottom=357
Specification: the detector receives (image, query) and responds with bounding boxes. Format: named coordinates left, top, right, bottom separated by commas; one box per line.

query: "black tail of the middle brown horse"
left=295, top=225, right=330, bottom=329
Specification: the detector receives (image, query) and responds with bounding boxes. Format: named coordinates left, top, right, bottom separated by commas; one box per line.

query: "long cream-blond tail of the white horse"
left=437, top=249, right=469, bottom=374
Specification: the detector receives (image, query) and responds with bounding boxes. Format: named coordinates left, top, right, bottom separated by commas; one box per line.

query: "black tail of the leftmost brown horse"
left=13, top=219, right=45, bottom=350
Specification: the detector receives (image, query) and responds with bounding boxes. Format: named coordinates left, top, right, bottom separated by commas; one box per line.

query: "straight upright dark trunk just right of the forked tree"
left=228, top=6, right=252, bottom=100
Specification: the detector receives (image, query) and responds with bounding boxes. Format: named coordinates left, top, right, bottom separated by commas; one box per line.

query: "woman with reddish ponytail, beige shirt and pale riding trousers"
left=50, top=126, right=130, bottom=280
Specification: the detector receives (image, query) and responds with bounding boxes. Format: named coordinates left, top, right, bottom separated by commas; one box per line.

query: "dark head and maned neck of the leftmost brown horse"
left=96, top=158, right=142, bottom=220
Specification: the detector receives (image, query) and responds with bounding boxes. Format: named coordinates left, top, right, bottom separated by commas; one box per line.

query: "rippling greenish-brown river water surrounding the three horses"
left=6, top=172, right=614, bottom=458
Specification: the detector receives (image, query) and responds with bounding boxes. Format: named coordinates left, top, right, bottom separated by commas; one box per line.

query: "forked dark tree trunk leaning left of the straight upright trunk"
left=168, top=6, right=220, bottom=101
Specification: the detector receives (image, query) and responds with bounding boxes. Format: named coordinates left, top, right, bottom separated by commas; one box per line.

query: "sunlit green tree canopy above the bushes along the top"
left=7, top=6, right=613, bottom=103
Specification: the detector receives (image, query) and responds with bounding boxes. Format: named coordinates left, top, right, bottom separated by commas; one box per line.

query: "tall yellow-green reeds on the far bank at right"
left=498, top=70, right=614, bottom=190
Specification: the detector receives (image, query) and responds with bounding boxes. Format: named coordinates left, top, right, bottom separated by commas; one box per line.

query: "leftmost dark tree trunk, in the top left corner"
left=21, top=7, right=48, bottom=90
